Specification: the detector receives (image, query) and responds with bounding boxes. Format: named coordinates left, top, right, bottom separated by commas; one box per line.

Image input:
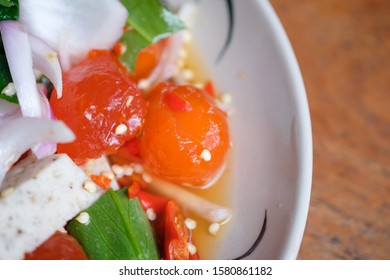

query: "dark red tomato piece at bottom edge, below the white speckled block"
left=25, top=232, right=88, bottom=260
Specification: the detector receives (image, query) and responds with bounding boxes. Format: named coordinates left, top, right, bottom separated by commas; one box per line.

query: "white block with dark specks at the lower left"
left=0, top=154, right=104, bottom=259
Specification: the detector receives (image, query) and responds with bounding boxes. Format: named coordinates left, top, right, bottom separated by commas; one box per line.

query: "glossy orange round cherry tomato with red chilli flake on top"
left=140, top=82, right=230, bottom=186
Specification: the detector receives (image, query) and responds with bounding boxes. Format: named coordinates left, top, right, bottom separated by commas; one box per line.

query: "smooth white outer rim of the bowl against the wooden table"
left=257, top=0, right=313, bottom=259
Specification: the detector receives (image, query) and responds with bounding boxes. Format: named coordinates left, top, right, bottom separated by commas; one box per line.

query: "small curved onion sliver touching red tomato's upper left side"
left=28, top=35, right=62, bottom=98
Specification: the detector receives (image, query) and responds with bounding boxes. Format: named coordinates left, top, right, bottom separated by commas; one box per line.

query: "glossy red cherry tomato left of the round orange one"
left=50, top=51, right=146, bottom=163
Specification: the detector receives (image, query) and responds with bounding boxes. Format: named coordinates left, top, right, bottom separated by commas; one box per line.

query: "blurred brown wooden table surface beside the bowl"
left=270, top=0, right=390, bottom=259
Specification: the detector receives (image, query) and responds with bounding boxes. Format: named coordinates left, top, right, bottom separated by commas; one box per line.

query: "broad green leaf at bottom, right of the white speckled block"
left=66, top=189, right=158, bottom=260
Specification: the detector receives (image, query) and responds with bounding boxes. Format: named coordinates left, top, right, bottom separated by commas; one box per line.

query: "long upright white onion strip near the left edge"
left=0, top=21, right=42, bottom=117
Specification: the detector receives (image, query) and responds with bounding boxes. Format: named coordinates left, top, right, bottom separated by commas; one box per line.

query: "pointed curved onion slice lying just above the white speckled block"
left=0, top=117, right=75, bottom=185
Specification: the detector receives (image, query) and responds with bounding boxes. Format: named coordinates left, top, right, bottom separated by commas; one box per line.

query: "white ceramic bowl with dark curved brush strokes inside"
left=169, top=0, right=312, bottom=259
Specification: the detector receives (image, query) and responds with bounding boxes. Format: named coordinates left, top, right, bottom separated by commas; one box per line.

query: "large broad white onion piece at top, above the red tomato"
left=19, top=0, right=128, bottom=69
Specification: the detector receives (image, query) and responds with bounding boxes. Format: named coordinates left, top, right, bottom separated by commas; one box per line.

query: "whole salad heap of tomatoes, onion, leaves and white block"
left=0, top=0, right=231, bottom=259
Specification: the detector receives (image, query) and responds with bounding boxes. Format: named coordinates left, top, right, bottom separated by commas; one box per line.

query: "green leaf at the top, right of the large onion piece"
left=120, top=0, right=185, bottom=72
